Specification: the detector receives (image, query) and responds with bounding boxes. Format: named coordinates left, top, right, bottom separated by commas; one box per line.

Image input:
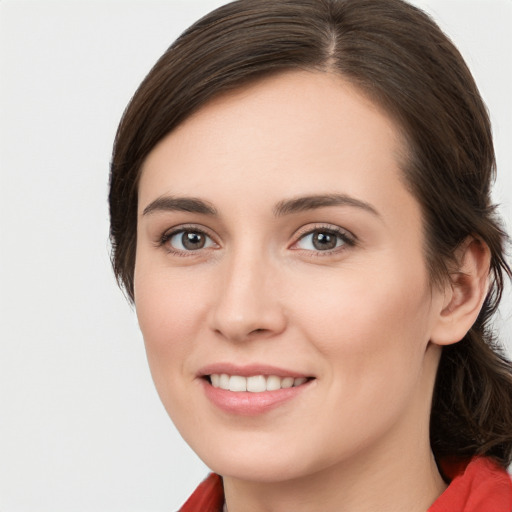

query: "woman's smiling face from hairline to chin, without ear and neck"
left=135, top=72, right=444, bottom=481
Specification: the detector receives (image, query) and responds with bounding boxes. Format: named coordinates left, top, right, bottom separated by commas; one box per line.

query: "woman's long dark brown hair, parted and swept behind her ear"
left=109, top=0, right=512, bottom=465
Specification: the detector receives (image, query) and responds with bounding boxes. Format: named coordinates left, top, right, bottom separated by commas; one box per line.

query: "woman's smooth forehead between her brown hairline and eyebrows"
left=139, top=71, right=414, bottom=218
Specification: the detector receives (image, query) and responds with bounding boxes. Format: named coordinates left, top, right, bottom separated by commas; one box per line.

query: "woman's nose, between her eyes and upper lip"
left=210, top=250, right=286, bottom=342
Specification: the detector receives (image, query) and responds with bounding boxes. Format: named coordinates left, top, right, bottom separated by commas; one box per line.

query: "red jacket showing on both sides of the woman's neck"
left=179, top=457, right=512, bottom=512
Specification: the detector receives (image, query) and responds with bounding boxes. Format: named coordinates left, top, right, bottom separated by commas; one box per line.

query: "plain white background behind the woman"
left=0, top=0, right=512, bottom=512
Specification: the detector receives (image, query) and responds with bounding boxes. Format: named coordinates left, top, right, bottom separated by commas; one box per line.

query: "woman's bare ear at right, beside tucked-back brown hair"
left=430, top=237, right=491, bottom=345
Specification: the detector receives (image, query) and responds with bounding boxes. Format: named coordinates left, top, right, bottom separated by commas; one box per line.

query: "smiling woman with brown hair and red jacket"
left=110, top=0, right=512, bottom=512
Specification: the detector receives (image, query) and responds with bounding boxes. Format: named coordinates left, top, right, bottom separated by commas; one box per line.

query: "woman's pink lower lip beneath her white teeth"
left=203, top=379, right=312, bottom=416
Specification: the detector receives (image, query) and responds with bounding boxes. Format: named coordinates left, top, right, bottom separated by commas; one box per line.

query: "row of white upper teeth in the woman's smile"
left=210, top=373, right=308, bottom=393
